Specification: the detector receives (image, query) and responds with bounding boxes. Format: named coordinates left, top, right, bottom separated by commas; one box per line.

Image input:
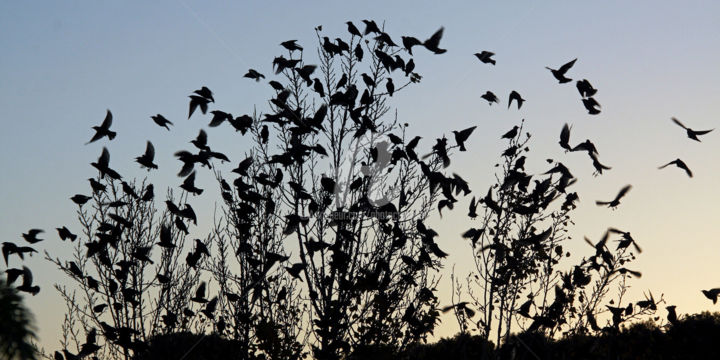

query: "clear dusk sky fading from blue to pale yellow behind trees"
left=0, top=0, right=720, bottom=348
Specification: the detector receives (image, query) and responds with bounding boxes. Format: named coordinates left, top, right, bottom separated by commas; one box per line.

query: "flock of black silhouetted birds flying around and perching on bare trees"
left=2, top=20, right=720, bottom=348
